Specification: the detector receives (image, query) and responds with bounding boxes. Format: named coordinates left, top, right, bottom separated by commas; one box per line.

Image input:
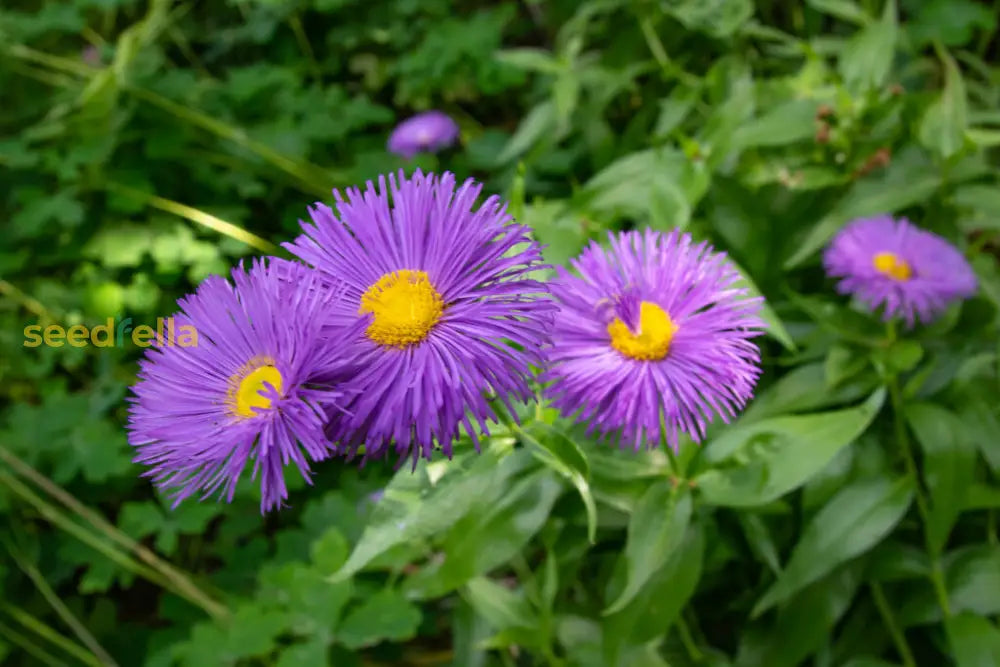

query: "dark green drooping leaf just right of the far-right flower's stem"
left=906, top=403, right=976, bottom=553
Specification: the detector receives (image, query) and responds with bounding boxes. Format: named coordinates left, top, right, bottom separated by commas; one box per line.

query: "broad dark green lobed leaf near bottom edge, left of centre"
left=337, top=588, right=421, bottom=649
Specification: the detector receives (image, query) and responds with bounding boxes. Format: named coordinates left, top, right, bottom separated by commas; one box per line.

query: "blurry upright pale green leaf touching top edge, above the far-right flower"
left=839, top=0, right=898, bottom=94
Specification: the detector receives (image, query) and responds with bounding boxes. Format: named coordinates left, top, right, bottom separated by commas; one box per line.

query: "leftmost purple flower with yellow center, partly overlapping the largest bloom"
left=128, top=259, right=362, bottom=513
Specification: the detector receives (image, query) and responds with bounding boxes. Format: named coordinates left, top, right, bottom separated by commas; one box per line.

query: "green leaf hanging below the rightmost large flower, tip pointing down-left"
left=604, top=480, right=692, bottom=616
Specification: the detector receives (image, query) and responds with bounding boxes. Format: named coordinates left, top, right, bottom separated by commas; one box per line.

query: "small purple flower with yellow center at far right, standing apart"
left=823, top=215, right=977, bottom=327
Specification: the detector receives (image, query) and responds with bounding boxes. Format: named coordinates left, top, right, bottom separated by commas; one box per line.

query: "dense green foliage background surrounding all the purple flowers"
left=0, top=0, right=1000, bottom=667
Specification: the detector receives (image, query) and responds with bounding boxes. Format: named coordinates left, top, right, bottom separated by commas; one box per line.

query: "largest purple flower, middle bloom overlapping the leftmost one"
left=285, top=170, right=555, bottom=465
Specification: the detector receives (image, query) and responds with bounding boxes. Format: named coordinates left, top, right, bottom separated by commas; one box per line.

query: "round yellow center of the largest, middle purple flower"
left=358, top=269, right=444, bottom=348
